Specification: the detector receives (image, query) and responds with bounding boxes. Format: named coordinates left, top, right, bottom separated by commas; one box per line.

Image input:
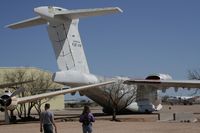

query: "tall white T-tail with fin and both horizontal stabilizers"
left=7, top=6, right=122, bottom=73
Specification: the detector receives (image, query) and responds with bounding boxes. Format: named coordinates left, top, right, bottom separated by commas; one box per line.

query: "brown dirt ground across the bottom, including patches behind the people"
left=0, top=105, right=200, bottom=133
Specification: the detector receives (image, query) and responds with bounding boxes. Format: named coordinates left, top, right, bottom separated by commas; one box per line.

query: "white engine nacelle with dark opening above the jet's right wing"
left=145, top=74, right=172, bottom=80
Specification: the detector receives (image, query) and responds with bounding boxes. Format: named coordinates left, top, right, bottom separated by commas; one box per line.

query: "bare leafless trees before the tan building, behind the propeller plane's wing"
left=4, top=69, right=62, bottom=118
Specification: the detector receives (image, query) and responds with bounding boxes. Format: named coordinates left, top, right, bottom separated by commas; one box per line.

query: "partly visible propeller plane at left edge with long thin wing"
left=0, top=81, right=112, bottom=124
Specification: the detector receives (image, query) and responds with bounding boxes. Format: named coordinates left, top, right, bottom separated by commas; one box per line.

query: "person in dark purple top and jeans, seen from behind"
left=79, top=106, right=95, bottom=133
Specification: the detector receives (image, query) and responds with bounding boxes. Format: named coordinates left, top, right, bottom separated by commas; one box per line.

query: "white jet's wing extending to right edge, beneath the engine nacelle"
left=124, top=80, right=200, bottom=88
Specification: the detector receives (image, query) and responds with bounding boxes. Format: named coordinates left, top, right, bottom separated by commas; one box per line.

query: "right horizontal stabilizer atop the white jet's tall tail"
left=55, top=7, right=122, bottom=19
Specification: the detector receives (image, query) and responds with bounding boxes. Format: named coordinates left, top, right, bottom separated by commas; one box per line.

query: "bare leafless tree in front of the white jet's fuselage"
left=104, top=80, right=136, bottom=121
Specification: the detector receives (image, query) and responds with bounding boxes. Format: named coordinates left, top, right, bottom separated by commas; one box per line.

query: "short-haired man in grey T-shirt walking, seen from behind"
left=40, top=103, right=57, bottom=133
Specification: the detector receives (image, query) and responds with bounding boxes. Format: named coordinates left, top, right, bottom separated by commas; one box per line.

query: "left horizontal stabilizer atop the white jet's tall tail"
left=6, top=16, right=47, bottom=29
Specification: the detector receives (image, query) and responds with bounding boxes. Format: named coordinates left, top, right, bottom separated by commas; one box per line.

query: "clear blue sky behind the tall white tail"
left=0, top=0, right=200, bottom=79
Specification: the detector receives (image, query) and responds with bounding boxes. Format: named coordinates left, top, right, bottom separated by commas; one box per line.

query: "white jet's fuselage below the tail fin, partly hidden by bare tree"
left=53, top=70, right=160, bottom=113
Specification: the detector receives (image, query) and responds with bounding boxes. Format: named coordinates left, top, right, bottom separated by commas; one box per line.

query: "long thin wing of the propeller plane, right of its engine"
left=18, top=81, right=115, bottom=104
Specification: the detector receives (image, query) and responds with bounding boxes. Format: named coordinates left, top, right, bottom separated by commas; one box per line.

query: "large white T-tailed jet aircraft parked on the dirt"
left=6, top=6, right=200, bottom=113
